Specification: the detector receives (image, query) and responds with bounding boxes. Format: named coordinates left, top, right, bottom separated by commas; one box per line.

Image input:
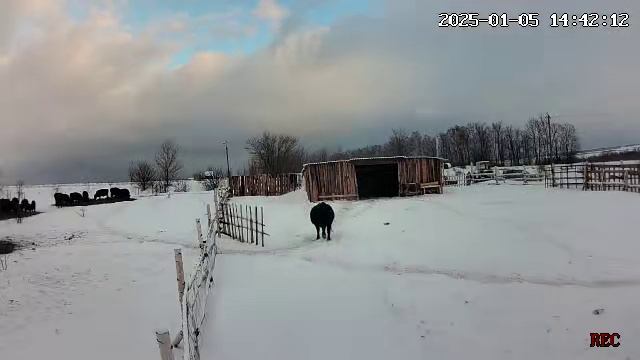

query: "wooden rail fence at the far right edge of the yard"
left=544, top=164, right=640, bottom=192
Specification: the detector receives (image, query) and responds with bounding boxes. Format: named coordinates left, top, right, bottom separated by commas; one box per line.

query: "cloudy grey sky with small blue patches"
left=0, top=0, right=640, bottom=183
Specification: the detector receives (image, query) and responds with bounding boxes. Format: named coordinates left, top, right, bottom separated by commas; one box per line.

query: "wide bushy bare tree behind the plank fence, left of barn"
left=246, top=132, right=304, bottom=175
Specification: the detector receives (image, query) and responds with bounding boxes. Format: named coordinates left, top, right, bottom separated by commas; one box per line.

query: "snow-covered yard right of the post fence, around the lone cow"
left=203, top=185, right=640, bottom=359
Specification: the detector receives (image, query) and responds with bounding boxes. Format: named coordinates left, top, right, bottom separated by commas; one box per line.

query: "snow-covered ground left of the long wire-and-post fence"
left=0, top=184, right=213, bottom=360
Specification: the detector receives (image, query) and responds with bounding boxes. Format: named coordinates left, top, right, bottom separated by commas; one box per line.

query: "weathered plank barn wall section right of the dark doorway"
left=398, top=158, right=443, bottom=196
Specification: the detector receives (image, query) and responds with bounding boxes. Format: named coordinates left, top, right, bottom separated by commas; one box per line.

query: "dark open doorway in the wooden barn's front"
left=355, top=163, right=400, bottom=199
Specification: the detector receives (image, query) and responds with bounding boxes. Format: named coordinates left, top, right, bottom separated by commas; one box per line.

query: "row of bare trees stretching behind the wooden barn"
left=242, top=114, right=579, bottom=174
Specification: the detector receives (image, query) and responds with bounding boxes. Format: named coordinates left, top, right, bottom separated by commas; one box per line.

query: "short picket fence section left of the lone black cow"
left=218, top=203, right=269, bottom=247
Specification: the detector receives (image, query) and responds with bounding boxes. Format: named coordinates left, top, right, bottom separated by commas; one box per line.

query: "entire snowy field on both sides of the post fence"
left=0, top=184, right=640, bottom=360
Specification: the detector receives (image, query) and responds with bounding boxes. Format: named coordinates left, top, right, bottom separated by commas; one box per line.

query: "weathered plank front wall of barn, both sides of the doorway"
left=303, top=158, right=443, bottom=202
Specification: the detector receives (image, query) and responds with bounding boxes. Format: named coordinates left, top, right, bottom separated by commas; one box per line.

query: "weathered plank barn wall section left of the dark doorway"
left=303, top=161, right=358, bottom=202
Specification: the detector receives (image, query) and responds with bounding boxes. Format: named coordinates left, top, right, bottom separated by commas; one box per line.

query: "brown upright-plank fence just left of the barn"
left=229, top=174, right=302, bottom=196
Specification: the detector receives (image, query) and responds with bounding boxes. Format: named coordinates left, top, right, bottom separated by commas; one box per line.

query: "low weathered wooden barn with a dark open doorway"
left=302, top=156, right=443, bottom=202
